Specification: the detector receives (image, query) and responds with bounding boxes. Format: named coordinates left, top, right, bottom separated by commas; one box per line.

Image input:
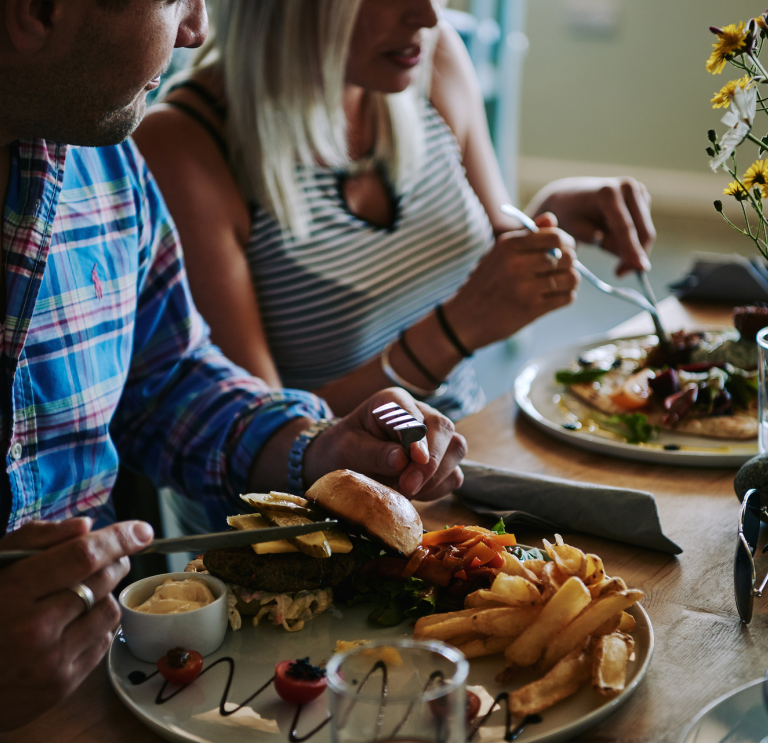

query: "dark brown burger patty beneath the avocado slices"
left=203, top=547, right=357, bottom=593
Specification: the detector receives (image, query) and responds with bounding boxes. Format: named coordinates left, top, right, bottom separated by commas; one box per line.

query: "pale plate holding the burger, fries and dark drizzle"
left=108, top=605, right=653, bottom=743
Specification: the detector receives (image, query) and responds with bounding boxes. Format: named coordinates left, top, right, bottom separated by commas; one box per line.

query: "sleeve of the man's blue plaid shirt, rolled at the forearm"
left=110, top=145, right=330, bottom=520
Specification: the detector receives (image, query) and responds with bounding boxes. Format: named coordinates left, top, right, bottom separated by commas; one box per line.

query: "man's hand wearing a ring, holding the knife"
left=0, top=518, right=152, bottom=731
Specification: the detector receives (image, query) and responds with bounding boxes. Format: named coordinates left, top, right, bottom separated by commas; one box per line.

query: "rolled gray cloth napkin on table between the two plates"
left=456, top=461, right=683, bottom=555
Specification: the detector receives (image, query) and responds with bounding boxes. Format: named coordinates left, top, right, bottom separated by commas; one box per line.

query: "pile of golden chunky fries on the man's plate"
left=413, top=534, right=643, bottom=717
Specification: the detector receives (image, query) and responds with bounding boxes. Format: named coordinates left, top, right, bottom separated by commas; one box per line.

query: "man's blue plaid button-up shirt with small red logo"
left=0, top=140, right=328, bottom=533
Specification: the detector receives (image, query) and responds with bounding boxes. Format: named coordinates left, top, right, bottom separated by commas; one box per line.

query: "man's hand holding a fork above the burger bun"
left=304, top=387, right=467, bottom=500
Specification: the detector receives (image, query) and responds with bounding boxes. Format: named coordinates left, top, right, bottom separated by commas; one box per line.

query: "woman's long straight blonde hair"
left=197, top=0, right=432, bottom=236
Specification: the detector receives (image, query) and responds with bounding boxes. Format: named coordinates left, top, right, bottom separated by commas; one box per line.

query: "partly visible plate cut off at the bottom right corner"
left=680, top=679, right=768, bottom=743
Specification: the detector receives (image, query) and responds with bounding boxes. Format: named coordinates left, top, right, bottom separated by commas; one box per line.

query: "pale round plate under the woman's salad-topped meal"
left=515, top=333, right=758, bottom=467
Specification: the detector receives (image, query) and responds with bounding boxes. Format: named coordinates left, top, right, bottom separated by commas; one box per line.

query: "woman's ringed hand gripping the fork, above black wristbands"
left=444, top=214, right=579, bottom=350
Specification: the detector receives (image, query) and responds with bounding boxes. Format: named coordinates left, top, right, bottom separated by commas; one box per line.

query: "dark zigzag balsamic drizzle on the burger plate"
left=128, top=656, right=542, bottom=743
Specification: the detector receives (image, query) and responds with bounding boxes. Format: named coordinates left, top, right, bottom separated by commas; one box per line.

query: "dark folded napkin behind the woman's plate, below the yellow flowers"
left=669, top=254, right=768, bottom=304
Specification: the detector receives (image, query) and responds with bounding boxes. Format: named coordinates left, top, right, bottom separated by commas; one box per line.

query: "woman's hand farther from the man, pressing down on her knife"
left=529, top=178, right=656, bottom=276
